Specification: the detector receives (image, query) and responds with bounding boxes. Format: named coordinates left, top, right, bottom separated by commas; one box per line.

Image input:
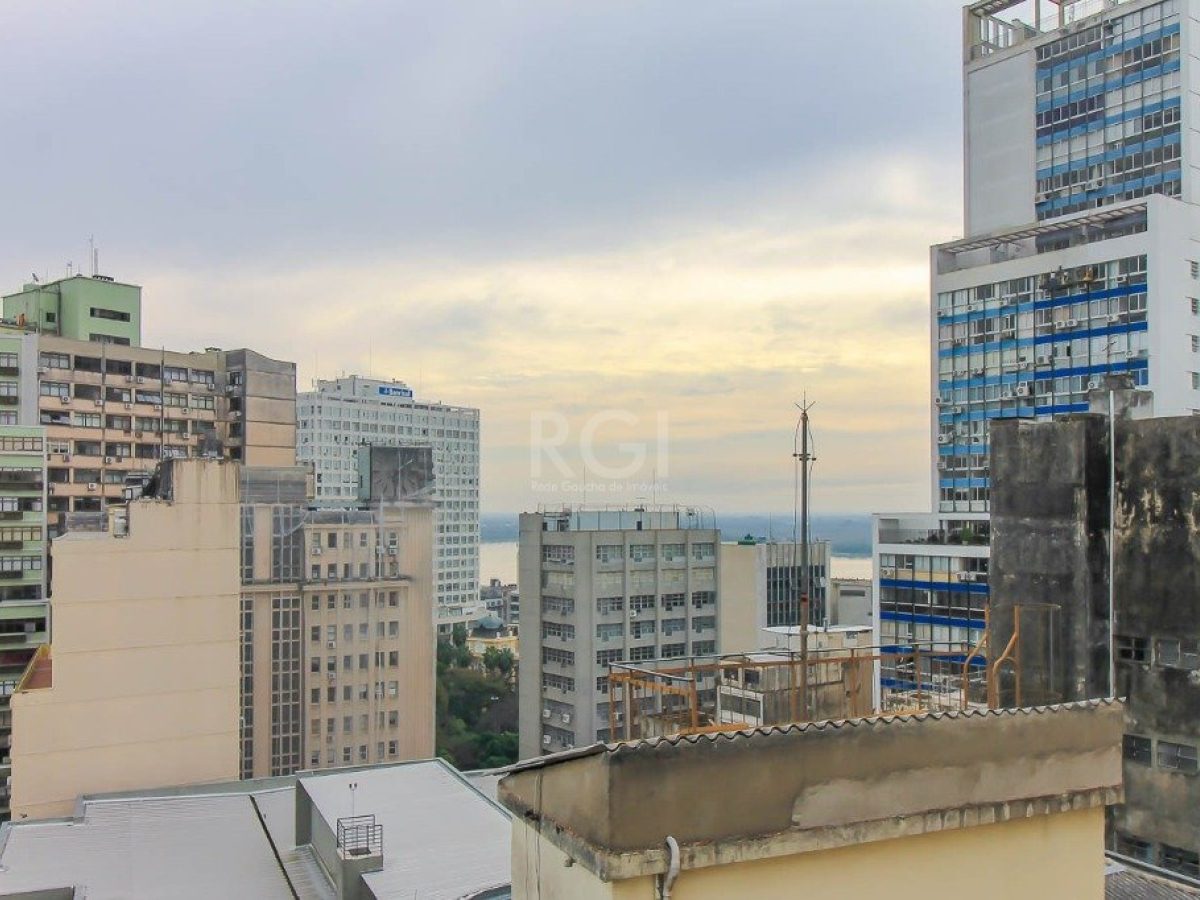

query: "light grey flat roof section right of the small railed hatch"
left=301, top=760, right=512, bottom=900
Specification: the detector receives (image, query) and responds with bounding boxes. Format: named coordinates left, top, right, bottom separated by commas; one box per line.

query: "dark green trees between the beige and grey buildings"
left=437, top=625, right=517, bottom=769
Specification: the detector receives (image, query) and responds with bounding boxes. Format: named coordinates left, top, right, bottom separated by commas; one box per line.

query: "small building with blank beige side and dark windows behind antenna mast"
left=718, top=535, right=829, bottom=653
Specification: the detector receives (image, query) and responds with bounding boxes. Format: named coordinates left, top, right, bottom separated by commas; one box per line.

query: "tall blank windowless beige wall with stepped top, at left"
left=11, top=460, right=239, bottom=818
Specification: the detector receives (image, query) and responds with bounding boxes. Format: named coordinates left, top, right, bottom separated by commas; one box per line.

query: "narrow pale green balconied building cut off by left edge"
left=0, top=328, right=49, bottom=820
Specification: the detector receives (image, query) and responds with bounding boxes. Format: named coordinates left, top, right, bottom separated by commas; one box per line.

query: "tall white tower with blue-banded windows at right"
left=874, top=0, right=1200, bottom=678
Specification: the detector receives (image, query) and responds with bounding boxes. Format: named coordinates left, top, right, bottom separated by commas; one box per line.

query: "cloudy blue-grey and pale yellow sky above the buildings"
left=0, top=0, right=961, bottom=512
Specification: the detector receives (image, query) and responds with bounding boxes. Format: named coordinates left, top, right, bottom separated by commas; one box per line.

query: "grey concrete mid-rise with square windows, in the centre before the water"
left=518, top=508, right=721, bottom=757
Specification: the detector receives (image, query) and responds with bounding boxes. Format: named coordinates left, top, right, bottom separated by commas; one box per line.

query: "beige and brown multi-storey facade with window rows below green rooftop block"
left=37, top=334, right=295, bottom=532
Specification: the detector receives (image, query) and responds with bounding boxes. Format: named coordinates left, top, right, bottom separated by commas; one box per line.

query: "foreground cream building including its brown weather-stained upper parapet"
left=499, top=702, right=1123, bottom=900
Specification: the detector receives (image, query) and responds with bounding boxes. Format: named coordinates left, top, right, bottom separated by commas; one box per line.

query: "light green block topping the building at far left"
left=4, top=275, right=142, bottom=347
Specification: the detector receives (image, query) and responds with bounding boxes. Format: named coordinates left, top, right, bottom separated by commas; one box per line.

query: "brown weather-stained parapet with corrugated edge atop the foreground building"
left=499, top=701, right=1124, bottom=880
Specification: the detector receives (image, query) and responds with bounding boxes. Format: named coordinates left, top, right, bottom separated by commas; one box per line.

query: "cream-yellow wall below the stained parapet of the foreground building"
left=512, top=808, right=1104, bottom=900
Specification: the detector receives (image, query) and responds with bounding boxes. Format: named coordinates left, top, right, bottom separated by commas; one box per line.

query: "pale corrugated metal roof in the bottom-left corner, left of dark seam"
left=0, top=794, right=292, bottom=900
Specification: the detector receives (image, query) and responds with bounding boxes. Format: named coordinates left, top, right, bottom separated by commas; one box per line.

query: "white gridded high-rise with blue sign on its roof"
left=296, top=376, right=486, bottom=634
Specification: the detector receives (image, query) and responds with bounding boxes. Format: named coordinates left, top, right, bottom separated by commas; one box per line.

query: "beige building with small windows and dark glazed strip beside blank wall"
left=240, top=467, right=436, bottom=778
